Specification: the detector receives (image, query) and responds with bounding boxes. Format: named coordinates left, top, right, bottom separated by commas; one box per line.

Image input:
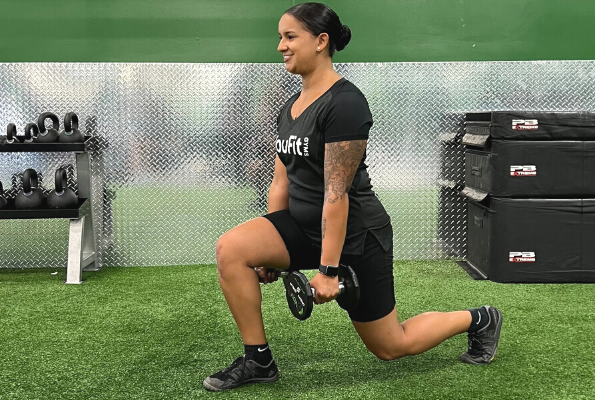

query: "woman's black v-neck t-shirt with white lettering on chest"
left=276, top=78, right=392, bottom=255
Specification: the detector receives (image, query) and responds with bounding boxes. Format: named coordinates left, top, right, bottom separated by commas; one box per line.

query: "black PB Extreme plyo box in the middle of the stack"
left=465, top=140, right=595, bottom=198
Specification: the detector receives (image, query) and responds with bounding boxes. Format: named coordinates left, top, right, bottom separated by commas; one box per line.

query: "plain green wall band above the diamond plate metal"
left=0, top=0, right=594, bottom=63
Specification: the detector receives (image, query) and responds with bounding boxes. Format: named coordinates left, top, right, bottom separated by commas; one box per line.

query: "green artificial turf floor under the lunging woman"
left=0, top=261, right=594, bottom=400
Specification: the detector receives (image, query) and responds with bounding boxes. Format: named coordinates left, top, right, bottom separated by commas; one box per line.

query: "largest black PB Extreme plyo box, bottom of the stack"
left=467, top=197, right=595, bottom=283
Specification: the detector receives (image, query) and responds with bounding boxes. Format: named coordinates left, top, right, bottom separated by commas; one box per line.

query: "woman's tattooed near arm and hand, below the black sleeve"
left=311, top=140, right=367, bottom=304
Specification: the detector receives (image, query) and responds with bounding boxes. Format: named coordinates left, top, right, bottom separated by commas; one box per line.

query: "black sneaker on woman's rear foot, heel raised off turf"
left=460, top=306, right=502, bottom=364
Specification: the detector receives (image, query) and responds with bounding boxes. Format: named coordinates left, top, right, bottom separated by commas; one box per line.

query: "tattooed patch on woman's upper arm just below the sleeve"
left=324, top=140, right=367, bottom=204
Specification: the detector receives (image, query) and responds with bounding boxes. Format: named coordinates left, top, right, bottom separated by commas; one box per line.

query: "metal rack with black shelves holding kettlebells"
left=0, top=135, right=100, bottom=284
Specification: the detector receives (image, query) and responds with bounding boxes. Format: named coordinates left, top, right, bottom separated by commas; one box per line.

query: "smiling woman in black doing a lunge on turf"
left=204, top=3, right=502, bottom=391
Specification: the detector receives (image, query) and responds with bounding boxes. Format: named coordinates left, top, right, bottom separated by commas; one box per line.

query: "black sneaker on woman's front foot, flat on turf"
left=204, top=355, right=279, bottom=392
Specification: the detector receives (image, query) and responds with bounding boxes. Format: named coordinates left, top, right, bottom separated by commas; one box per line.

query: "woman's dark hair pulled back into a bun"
left=285, top=3, right=352, bottom=57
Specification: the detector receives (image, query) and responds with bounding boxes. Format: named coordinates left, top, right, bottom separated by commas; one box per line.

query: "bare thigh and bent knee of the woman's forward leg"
left=217, top=217, right=290, bottom=269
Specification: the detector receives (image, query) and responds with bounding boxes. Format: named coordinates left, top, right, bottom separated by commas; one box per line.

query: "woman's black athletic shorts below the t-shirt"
left=264, top=209, right=396, bottom=322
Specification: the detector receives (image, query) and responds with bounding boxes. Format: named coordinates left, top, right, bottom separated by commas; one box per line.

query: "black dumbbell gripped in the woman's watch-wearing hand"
left=254, top=264, right=360, bottom=321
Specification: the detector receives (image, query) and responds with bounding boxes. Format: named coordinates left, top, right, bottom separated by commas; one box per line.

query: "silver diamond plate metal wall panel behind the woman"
left=0, top=61, right=595, bottom=268
